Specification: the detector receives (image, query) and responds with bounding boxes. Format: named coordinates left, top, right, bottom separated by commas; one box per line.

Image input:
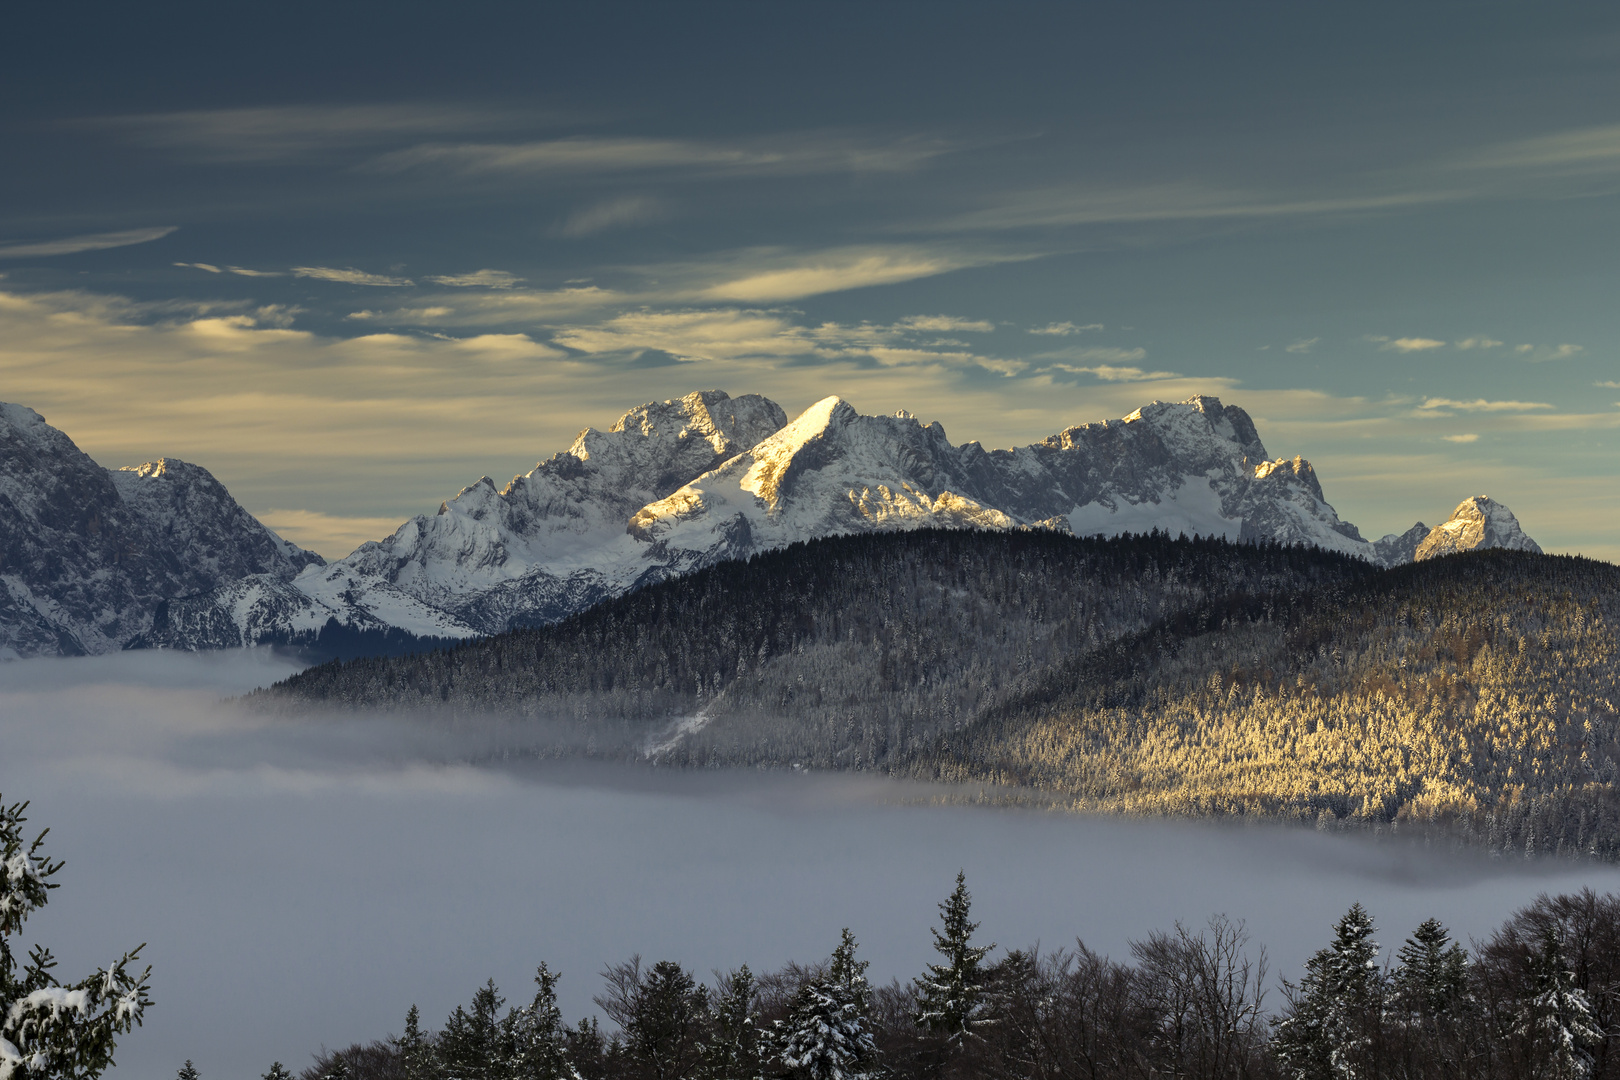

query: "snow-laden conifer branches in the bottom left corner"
left=0, top=801, right=150, bottom=1080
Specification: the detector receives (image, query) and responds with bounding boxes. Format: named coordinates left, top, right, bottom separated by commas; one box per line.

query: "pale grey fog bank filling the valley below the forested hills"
left=0, top=651, right=1620, bottom=1080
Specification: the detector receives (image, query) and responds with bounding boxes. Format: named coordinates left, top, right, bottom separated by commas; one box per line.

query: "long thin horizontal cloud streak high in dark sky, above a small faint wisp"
left=366, top=134, right=954, bottom=176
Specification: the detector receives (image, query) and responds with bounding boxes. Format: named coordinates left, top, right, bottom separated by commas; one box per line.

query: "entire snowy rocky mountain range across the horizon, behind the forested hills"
left=0, top=390, right=1539, bottom=656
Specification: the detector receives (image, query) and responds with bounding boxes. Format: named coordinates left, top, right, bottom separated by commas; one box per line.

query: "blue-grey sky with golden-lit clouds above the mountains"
left=0, top=2, right=1620, bottom=560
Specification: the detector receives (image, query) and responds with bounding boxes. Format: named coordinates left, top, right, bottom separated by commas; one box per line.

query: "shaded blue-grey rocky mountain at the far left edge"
left=0, top=403, right=322, bottom=656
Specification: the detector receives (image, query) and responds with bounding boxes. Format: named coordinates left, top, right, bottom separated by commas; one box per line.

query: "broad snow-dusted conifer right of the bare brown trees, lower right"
left=1272, top=904, right=1385, bottom=1080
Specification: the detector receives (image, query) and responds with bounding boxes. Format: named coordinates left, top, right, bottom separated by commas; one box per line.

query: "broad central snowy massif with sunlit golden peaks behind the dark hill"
left=151, top=390, right=1377, bottom=648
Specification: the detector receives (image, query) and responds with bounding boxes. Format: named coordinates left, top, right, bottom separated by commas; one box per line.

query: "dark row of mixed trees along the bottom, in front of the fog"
left=243, top=876, right=1620, bottom=1080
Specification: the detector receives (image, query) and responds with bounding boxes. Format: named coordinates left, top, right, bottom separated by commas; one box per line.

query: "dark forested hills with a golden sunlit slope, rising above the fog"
left=259, top=531, right=1620, bottom=860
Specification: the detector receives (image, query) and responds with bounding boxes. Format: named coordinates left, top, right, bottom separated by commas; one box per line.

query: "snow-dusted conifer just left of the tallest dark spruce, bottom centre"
left=774, top=928, right=878, bottom=1080
